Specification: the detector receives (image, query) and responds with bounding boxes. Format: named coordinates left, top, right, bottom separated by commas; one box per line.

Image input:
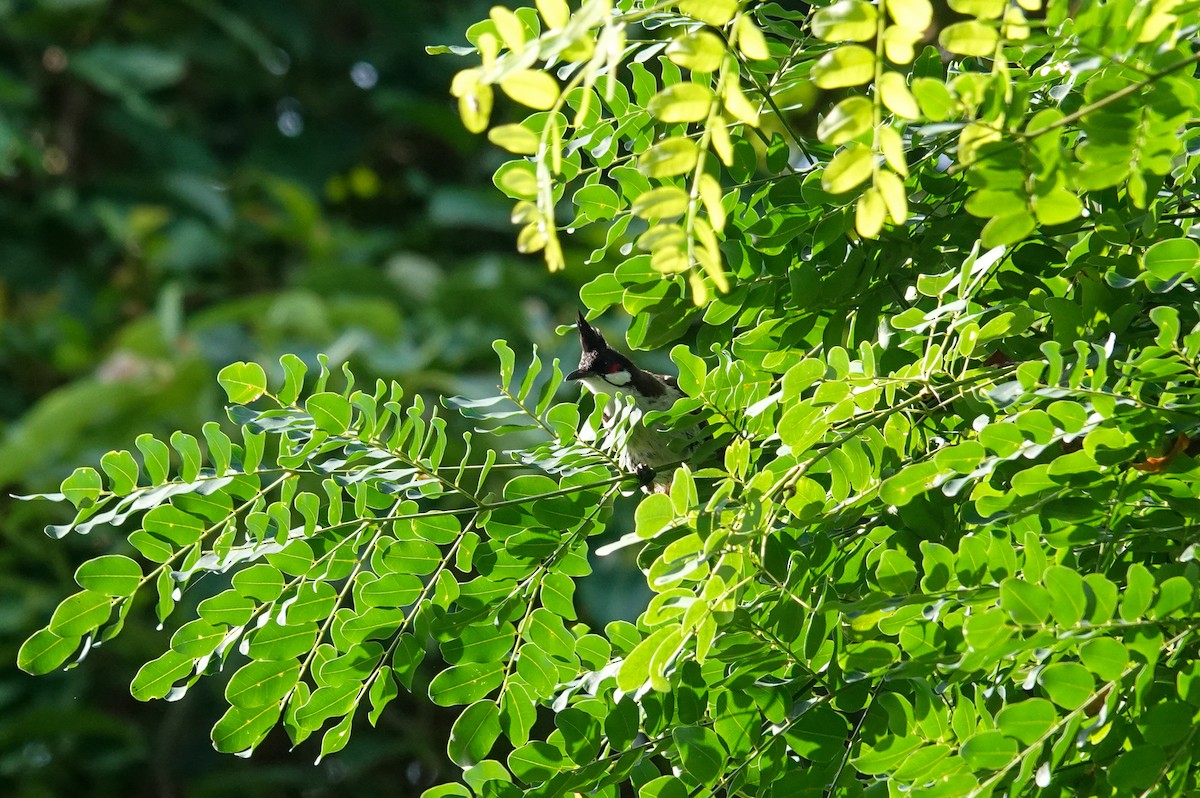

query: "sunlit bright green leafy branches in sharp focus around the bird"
left=20, top=0, right=1200, bottom=796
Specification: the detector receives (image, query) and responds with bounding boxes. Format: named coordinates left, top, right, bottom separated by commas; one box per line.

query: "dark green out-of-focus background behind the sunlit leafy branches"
left=0, top=0, right=637, bottom=798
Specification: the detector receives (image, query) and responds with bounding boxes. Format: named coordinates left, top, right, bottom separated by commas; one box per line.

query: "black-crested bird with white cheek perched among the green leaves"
left=566, top=311, right=692, bottom=493
